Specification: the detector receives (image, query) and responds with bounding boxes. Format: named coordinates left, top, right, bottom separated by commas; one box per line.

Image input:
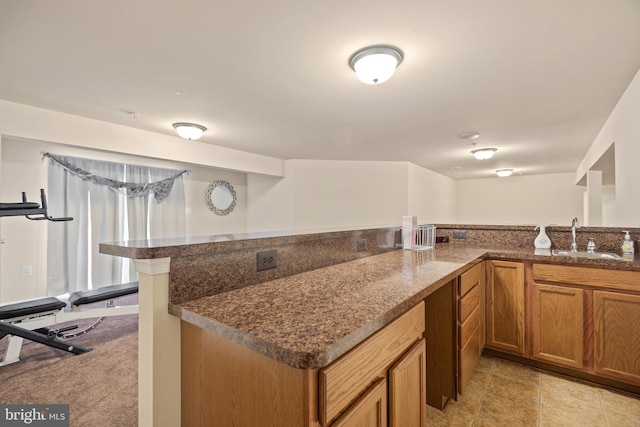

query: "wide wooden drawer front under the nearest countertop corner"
left=319, top=302, right=425, bottom=425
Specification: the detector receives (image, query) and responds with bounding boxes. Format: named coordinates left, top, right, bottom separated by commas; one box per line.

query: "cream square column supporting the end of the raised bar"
left=133, top=258, right=181, bottom=427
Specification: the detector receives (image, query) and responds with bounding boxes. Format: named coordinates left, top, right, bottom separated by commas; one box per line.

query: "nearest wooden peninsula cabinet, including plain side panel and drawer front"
left=181, top=302, right=426, bottom=427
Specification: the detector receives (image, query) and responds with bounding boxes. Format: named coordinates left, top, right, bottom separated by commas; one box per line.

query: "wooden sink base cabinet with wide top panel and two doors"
left=527, top=263, right=640, bottom=393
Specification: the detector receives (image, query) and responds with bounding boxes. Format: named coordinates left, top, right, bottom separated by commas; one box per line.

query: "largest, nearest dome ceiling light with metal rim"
left=349, top=45, right=404, bottom=85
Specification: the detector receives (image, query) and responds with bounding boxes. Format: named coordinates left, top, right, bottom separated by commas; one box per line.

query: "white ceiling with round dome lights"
left=0, top=0, right=640, bottom=179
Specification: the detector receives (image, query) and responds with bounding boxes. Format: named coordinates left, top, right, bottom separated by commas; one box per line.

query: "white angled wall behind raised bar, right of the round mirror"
left=247, top=160, right=455, bottom=231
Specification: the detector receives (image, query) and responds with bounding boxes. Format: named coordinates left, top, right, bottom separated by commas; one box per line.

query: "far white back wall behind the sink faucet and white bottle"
left=456, top=173, right=584, bottom=225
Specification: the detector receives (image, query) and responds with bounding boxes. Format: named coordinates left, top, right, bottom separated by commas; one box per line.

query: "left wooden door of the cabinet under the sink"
left=531, top=283, right=584, bottom=369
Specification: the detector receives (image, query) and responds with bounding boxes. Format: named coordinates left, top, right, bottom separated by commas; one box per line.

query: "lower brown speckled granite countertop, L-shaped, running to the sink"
left=170, top=244, right=640, bottom=369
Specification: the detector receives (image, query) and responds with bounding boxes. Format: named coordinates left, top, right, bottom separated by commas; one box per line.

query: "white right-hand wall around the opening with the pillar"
left=574, top=67, right=640, bottom=227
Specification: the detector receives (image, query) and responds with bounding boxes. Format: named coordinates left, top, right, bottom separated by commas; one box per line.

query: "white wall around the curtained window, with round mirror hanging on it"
left=0, top=136, right=247, bottom=302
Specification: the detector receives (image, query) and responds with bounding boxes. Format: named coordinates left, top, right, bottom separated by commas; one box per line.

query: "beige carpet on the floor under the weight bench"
left=0, top=296, right=138, bottom=427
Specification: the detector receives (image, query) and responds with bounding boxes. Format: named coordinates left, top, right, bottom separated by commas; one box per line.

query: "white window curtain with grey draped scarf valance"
left=46, top=154, right=188, bottom=296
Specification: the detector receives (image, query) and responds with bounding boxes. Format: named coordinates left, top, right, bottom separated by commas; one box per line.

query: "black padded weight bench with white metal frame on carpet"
left=0, top=282, right=138, bottom=366
